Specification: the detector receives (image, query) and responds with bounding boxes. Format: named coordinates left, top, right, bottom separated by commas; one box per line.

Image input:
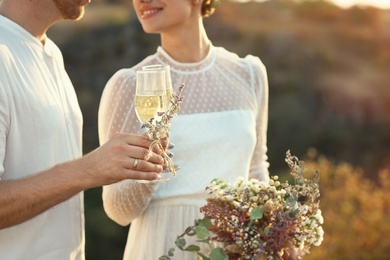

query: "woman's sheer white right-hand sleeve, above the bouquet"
left=246, top=56, right=269, bottom=181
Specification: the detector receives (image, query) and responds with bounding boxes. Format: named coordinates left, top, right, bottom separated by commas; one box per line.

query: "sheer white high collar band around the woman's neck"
left=157, top=45, right=216, bottom=73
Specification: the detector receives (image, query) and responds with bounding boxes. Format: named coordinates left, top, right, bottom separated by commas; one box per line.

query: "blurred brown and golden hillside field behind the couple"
left=49, top=0, right=390, bottom=260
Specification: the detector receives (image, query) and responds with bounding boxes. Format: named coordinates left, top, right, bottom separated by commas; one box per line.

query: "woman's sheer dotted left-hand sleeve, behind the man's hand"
left=99, top=69, right=159, bottom=226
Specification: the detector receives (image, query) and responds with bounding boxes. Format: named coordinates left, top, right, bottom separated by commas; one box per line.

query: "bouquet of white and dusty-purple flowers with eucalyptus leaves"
left=160, top=151, right=324, bottom=260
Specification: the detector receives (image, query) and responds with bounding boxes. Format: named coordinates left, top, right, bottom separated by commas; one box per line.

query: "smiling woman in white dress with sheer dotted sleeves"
left=99, top=0, right=269, bottom=260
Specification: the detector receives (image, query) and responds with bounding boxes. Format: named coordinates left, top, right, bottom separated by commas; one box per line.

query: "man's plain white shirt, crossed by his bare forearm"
left=0, top=16, right=84, bottom=260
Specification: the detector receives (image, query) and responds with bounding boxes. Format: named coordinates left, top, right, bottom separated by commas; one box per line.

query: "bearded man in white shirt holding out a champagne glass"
left=0, top=0, right=163, bottom=260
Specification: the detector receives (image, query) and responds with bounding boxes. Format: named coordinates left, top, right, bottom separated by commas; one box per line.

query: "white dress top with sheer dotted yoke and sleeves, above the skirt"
left=99, top=46, right=268, bottom=225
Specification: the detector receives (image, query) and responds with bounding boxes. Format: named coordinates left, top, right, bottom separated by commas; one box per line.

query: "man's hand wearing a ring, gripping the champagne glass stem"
left=77, top=134, right=166, bottom=186
